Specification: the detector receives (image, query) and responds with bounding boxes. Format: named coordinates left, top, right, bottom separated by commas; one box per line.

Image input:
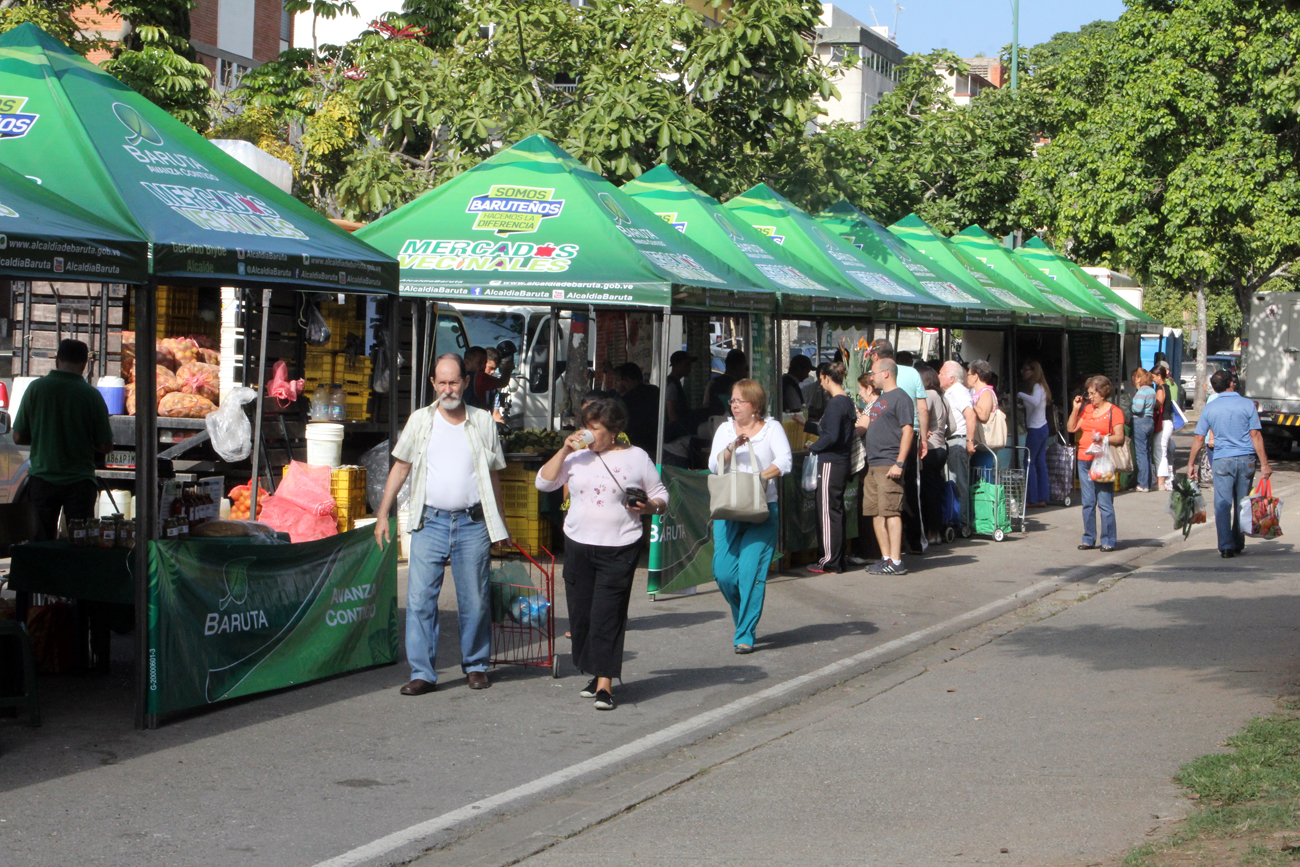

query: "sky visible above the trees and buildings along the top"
left=294, top=0, right=1125, bottom=57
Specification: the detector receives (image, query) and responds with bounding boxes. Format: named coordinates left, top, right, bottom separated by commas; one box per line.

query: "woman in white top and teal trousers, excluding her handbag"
left=709, top=380, right=793, bottom=654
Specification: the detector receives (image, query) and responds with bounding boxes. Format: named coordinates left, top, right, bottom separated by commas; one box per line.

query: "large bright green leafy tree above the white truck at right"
left=1022, top=0, right=1300, bottom=410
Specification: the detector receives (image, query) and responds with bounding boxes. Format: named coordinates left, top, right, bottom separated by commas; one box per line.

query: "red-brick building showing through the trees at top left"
left=77, top=0, right=294, bottom=90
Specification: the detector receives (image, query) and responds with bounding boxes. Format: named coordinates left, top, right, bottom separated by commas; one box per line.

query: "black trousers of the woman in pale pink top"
left=564, top=537, right=641, bottom=677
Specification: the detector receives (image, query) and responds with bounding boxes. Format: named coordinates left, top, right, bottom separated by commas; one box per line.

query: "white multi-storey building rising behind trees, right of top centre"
left=816, top=3, right=906, bottom=125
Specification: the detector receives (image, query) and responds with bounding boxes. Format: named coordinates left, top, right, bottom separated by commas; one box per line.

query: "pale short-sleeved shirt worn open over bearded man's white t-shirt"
left=393, top=403, right=510, bottom=542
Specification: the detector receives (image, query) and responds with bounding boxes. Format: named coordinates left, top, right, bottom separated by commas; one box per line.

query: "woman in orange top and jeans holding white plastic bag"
left=1066, top=376, right=1125, bottom=552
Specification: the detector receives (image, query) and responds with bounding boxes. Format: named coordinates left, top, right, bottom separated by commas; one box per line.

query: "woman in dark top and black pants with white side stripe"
left=809, top=361, right=858, bottom=573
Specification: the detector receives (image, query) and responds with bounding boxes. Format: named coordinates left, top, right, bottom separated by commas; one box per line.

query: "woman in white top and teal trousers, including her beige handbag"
left=709, top=380, right=793, bottom=654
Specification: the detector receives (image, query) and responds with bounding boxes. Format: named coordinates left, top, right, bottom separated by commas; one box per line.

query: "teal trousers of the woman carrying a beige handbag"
left=714, top=503, right=781, bottom=647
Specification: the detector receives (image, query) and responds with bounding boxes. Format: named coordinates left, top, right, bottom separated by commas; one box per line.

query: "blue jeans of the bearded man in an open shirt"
left=407, top=506, right=491, bottom=684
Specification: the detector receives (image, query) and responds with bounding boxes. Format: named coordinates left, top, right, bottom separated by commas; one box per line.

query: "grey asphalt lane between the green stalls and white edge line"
left=0, top=436, right=1289, bottom=866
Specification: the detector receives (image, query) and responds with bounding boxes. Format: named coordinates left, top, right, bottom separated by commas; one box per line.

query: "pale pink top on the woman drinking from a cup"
left=537, top=446, right=668, bottom=547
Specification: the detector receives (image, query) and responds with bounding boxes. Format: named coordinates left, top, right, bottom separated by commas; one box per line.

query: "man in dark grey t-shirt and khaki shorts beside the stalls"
left=858, top=359, right=915, bottom=575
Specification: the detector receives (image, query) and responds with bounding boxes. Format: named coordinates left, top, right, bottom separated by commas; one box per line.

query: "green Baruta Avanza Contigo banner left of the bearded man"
left=148, top=528, right=398, bottom=714
